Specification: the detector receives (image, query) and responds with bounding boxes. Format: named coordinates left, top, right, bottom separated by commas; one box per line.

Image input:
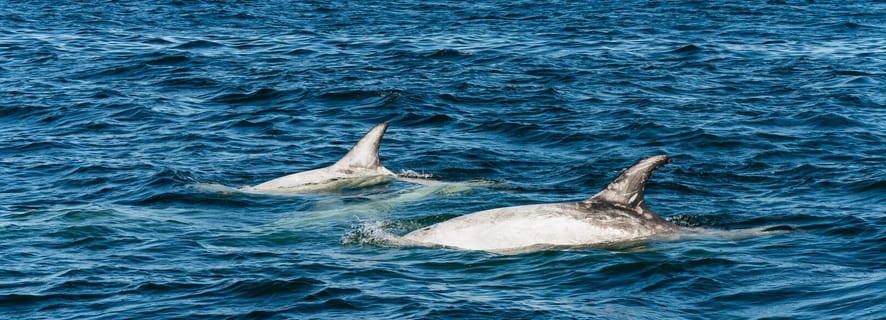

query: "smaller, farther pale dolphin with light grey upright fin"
left=240, top=122, right=397, bottom=193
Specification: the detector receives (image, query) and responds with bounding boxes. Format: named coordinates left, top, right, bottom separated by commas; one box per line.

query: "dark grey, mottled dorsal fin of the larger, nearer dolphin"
left=585, top=155, right=671, bottom=209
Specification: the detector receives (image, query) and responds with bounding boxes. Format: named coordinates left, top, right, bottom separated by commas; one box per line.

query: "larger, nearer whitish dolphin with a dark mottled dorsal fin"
left=401, top=155, right=681, bottom=253
